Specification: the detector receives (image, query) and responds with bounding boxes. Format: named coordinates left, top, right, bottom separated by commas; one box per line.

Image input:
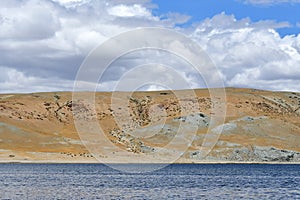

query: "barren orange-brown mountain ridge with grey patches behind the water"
left=0, top=88, right=300, bottom=163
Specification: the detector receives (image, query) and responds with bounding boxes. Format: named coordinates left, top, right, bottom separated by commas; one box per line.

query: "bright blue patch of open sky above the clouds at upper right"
left=152, top=0, right=300, bottom=36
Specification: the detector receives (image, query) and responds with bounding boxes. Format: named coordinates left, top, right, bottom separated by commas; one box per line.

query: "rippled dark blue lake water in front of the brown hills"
left=0, top=164, right=300, bottom=199
